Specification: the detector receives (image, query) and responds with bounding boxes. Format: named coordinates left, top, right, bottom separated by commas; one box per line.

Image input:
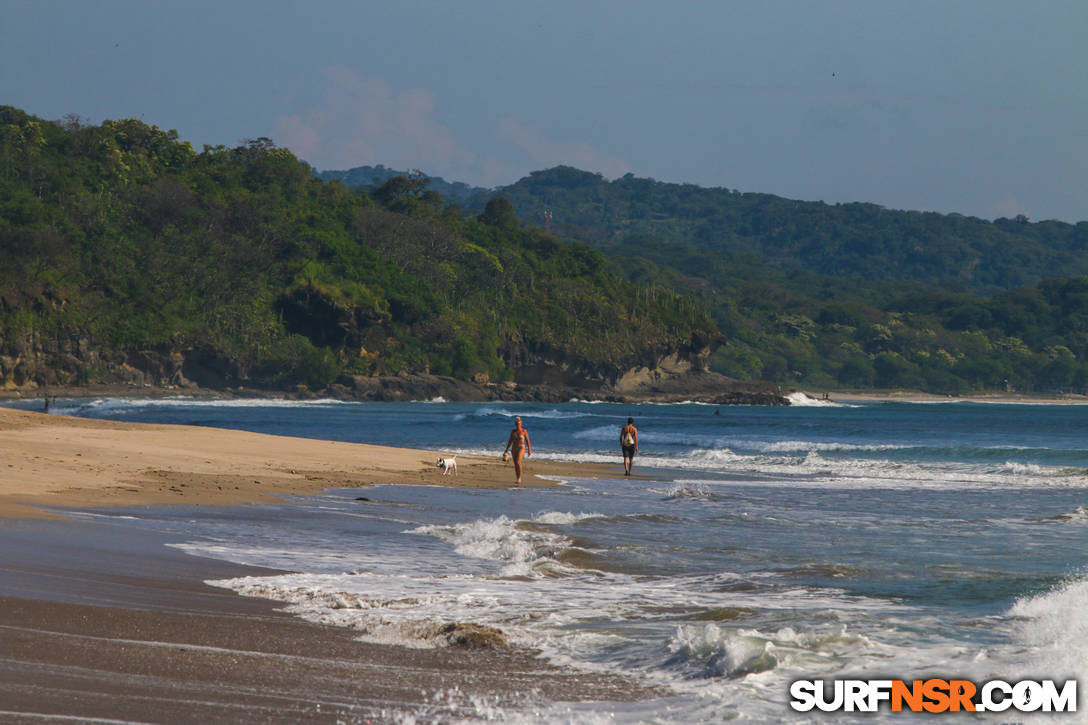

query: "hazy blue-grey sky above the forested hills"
left=0, top=0, right=1088, bottom=222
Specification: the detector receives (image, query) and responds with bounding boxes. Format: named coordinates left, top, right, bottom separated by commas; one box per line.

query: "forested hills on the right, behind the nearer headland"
left=326, top=167, right=1088, bottom=393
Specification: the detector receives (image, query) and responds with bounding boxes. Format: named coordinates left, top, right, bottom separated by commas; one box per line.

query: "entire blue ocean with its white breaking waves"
left=8, top=395, right=1088, bottom=723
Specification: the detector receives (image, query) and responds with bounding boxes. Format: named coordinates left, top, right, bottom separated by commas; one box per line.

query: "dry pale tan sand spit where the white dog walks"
left=0, top=408, right=622, bottom=517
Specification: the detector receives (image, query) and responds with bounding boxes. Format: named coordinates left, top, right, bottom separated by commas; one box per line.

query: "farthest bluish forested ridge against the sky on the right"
left=478, top=167, right=1088, bottom=294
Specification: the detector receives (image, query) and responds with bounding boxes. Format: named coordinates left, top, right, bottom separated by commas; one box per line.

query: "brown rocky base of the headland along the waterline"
left=0, top=326, right=789, bottom=405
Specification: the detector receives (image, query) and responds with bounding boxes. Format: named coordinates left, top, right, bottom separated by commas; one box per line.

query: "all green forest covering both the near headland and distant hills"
left=8, top=107, right=1088, bottom=393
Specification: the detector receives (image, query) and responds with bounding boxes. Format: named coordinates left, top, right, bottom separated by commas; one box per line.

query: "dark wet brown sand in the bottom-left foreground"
left=0, top=518, right=663, bottom=725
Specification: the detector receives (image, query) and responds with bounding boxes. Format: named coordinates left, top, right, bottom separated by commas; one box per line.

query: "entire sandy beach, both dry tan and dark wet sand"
left=0, top=408, right=651, bottom=723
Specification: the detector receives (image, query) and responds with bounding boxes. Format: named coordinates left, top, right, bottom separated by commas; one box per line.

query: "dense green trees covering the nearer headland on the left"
left=0, top=107, right=715, bottom=385
